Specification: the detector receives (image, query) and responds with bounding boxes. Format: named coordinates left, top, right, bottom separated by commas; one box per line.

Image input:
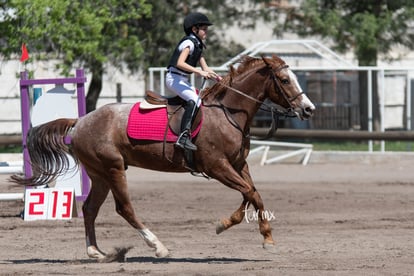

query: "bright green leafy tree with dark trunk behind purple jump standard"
left=0, top=0, right=151, bottom=111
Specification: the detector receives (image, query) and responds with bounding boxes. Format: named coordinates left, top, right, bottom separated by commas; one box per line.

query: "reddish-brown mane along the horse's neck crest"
left=203, top=55, right=285, bottom=99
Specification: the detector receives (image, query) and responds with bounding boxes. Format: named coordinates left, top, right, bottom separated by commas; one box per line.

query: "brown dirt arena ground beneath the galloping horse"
left=0, top=156, right=414, bottom=275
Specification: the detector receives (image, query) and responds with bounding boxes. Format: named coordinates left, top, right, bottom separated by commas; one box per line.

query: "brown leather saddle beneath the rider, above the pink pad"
left=144, top=90, right=202, bottom=135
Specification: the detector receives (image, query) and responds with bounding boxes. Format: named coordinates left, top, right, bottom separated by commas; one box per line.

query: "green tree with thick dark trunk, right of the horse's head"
left=273, top=0, right=414, bottom=129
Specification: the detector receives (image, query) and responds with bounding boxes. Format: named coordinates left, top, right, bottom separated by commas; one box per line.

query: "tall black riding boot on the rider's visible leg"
left=175, top=100, right=198, bottom=151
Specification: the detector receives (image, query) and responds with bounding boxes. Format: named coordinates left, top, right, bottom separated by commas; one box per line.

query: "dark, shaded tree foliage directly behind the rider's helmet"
left=129, top=0, right=263, bottom=69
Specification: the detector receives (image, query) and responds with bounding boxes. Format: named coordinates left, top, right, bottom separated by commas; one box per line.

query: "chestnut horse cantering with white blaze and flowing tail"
left=11, top=55, right=315, bottom=261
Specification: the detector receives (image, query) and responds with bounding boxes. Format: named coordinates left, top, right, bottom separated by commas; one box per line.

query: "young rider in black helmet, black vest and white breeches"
left=165, top=12, right=221, bottom=151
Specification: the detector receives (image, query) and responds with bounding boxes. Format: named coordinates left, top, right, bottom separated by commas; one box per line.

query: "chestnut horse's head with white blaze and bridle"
left=262, top=55, right=315, bottom=120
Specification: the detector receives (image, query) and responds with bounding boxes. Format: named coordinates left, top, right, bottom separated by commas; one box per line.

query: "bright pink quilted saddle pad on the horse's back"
left=127, top=102, right=202, bottom=142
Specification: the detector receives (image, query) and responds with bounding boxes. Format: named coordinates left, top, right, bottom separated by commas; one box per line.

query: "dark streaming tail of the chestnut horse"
left=10, top=119, right=79, bottom=186
